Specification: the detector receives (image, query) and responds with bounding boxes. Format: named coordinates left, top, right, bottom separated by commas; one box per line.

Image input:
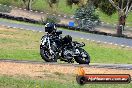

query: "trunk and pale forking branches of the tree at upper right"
left=109, top=0, right=132, bottom=36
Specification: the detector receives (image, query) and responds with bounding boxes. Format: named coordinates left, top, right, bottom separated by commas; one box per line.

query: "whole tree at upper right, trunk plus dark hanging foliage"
left=69, top=0, right=132, bottom=36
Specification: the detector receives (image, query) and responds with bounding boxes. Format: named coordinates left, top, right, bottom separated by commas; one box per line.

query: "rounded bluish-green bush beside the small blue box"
left=75, top=3, right=99, bottom=30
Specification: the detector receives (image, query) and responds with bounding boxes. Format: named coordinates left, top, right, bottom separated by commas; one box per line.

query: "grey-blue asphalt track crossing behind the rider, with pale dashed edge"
left=0, top=20, right=132, bottom=47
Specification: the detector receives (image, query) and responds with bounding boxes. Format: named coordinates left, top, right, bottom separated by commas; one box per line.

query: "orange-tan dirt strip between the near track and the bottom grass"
left=0, top=62, right=132, bottom=79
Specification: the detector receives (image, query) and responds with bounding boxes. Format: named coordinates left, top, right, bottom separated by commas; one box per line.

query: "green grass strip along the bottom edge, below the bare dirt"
left=0, top=76, right=132, bottom=88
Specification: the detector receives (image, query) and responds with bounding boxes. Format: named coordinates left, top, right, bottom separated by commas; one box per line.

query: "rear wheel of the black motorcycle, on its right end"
left=74, top=48, right=90, bottom=65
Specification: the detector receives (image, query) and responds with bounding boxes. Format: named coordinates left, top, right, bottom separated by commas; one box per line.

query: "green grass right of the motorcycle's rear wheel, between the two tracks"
left=85, top=42, right=132, bottom=64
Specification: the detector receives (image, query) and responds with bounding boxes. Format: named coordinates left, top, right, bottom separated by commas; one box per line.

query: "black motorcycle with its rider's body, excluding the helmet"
left=40, top=24, right=90, bottom=64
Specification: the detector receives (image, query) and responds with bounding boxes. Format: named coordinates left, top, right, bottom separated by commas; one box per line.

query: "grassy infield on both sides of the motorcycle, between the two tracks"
left=0, top=28, right=132, bottom=64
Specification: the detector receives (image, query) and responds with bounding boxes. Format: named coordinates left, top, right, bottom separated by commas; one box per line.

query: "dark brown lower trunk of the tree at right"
left=117, top=15, right=126, bottom=36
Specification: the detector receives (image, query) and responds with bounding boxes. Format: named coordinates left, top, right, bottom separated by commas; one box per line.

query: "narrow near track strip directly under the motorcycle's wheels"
left=0, top=59, right=132, bottom=71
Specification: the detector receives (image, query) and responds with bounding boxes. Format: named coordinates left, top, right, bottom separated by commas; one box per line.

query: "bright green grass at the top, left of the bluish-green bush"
left=33, top=0, right=77, bottom=15
